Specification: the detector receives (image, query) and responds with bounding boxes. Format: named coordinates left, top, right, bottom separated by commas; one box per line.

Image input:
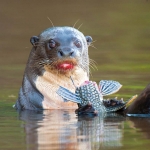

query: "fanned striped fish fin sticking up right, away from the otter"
left=99, top=80, right=122, bottom=96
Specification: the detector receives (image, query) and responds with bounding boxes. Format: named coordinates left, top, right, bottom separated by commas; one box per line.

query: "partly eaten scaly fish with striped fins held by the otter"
left=57, top=78, right=137, bottom=112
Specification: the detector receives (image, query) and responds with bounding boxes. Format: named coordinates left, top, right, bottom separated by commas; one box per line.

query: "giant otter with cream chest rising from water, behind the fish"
left=15, top=27, right=92, bottom=110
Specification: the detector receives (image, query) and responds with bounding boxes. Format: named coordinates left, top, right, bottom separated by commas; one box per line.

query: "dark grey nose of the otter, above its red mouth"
left=58, top=48, right=75, bottom=57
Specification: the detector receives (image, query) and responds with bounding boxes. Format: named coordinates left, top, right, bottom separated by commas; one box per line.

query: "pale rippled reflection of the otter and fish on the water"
left=19, top=110, right=124, bottom=150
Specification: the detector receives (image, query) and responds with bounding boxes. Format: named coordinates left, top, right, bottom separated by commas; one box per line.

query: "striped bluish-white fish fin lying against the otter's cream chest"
left=56, top=86, right=81, bottom=103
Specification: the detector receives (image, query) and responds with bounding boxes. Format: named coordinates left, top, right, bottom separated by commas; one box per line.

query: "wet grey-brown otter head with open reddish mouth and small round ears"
left=30, top=27, right=92, bottom=74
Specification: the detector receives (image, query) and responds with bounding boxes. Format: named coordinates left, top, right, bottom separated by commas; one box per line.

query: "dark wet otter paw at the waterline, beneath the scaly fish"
left=75, top=103, right=98, bottom=116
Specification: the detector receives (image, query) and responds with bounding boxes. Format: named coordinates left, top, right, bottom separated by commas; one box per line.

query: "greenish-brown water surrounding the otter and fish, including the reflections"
left=0, top=0, right=150, bottom=150
